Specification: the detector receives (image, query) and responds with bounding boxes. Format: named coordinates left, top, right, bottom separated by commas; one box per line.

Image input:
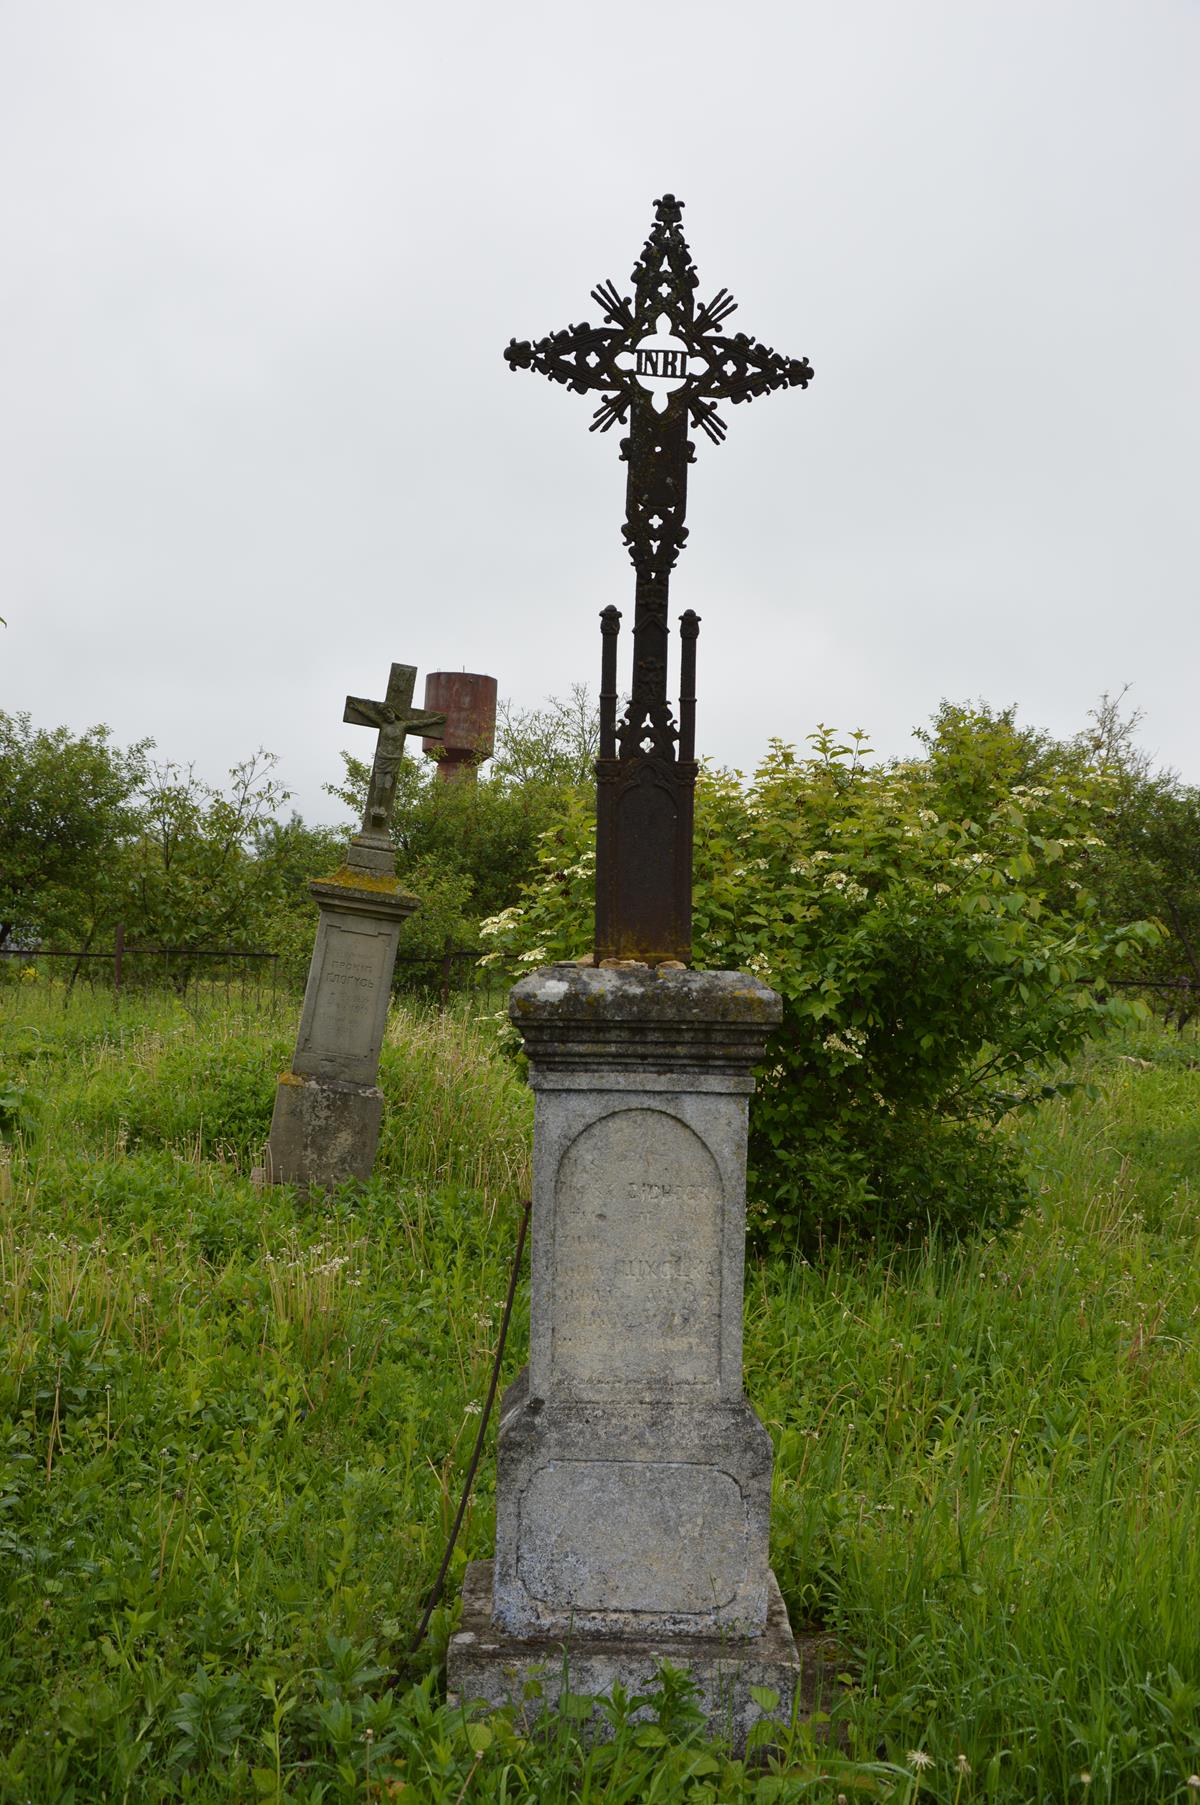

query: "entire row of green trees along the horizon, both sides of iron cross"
left=0, top=688, right=1200, bottom=984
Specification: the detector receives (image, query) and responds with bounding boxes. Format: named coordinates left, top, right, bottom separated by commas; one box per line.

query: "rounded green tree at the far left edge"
left=0, top=713, right=153, bottom=946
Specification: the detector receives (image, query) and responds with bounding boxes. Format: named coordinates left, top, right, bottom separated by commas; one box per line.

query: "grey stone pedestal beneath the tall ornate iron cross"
left=449, top=966, right=798, bottom=1735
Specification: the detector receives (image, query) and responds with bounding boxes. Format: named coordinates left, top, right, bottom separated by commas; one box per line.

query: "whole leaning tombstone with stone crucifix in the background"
left=262, top=664, right=446, bottom=1188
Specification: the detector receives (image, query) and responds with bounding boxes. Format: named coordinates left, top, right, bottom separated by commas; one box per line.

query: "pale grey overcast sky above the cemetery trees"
left=0, top=0, right=1200, bottom=818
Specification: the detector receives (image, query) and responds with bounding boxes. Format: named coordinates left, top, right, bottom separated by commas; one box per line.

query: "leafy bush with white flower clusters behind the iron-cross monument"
left=469, top=729, right=1155, bottom=1245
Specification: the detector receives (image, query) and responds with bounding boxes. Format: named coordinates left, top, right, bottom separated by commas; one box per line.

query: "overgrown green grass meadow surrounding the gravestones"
left=0, top=986, right=1200, bottom=1805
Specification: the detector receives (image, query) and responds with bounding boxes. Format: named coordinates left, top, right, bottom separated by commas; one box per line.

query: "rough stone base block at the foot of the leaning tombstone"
left=263, top=1072, right=383, bottom=1189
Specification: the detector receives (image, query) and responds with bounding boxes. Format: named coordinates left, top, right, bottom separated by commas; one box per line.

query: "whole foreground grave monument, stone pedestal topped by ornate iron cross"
left=449, top=195, right=812, bottom=1747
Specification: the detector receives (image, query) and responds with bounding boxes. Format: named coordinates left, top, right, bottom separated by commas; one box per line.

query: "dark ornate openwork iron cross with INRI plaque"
left=505, top=195, right=812, bottom=964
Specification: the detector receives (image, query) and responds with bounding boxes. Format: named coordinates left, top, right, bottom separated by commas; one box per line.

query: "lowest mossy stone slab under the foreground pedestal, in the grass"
left=446, top=1561, right=815, bottom=1753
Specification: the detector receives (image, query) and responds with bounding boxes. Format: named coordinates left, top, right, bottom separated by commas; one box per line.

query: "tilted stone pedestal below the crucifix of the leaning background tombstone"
left=263, top=855, right=419, bottom=1189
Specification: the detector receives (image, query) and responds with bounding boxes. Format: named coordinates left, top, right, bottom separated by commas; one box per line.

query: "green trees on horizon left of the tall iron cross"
left=0, top=691, right=595, bottom=962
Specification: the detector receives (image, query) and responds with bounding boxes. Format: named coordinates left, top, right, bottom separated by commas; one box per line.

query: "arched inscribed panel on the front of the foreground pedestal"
left=550, top=1110, right=724, bottom=1397
